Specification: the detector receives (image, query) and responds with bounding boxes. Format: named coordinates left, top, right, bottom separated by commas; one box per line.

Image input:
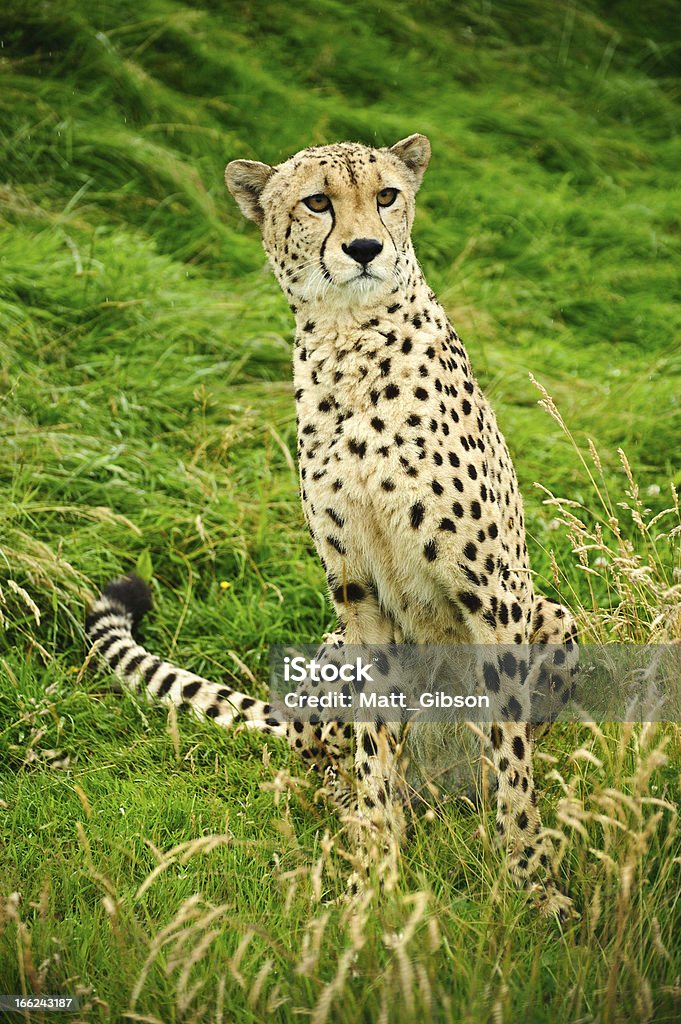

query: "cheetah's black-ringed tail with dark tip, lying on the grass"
left=85, top=574, right=287, bottom=736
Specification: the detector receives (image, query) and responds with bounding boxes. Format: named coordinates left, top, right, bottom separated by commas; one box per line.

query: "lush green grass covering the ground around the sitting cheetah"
left=0, top=0, right=681, bottom=1022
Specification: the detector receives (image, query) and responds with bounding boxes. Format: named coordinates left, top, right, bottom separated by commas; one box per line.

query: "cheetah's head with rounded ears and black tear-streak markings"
left=225, top=135, right=430, bottom=308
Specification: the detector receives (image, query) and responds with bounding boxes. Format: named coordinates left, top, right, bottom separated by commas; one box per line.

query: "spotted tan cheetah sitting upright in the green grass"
left=87, top=134, right=577, bottom=913
